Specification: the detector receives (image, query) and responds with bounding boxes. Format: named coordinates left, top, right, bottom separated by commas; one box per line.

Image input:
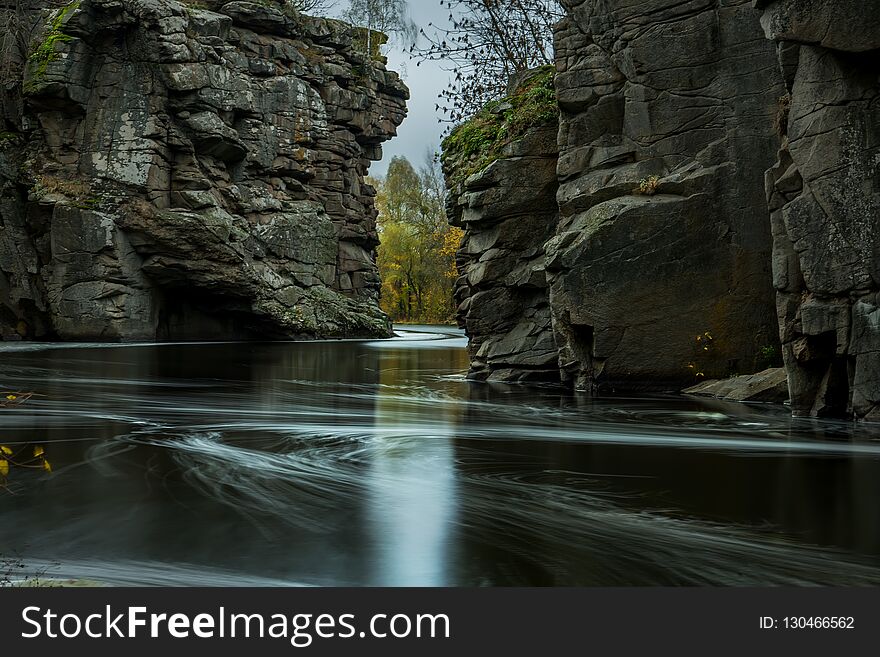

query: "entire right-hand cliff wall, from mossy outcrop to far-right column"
left=445, top=0, right=880, bottom=419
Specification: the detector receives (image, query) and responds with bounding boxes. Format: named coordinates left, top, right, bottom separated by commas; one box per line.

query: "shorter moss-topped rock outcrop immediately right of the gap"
left=443, top=66, right=559, bottom=381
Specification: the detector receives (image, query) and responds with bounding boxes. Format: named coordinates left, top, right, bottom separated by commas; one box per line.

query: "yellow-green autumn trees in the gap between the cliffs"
left=372, top=157, right=462, bottom=324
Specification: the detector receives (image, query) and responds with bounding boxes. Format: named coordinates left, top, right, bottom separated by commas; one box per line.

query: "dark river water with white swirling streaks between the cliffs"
left=0, top=327, right=880, bottom=586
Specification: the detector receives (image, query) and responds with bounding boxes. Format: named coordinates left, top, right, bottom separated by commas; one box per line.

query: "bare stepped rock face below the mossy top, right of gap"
left=449, top=127, right=559, bottom=381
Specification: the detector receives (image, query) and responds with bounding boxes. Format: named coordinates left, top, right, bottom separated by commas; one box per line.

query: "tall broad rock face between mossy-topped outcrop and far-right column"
left=547, top=0, right=784, bottom=390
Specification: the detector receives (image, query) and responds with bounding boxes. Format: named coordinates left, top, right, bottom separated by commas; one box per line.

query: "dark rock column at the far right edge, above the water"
left=754, top=0, right=880, bottom=420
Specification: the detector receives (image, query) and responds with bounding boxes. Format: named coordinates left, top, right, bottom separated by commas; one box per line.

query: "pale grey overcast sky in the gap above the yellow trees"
left=352, top=0, right=458, bottom=176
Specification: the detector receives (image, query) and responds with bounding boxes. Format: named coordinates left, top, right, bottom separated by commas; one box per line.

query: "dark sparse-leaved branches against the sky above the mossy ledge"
left=412, top=0, right=563, bottom=123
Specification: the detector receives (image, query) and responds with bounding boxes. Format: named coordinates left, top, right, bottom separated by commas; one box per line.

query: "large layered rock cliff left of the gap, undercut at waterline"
left=0, top=0, right=408, bottom=340
